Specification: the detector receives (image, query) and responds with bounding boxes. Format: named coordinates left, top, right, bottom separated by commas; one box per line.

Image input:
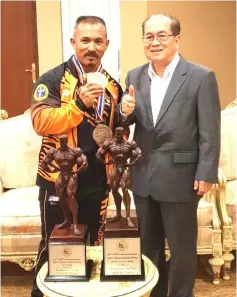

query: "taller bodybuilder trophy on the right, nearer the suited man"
left=96, top=127, right=145, bottom=281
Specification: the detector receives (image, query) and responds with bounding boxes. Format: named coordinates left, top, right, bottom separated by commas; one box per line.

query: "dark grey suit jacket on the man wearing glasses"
left=117, top=57, right=220, bottom=202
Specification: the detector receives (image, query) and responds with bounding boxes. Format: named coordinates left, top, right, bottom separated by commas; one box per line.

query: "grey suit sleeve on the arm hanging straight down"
left=195, top=72, right=220, bottom=183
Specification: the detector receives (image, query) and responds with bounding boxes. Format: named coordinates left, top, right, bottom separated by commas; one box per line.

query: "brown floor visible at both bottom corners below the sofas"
left=0, top=254, right=236, bottom=297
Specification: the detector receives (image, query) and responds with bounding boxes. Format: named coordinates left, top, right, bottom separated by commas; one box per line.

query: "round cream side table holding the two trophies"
left=37, top=246, right=159, bottom=297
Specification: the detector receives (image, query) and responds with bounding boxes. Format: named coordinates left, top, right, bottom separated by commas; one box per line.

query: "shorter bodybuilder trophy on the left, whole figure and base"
left=41, top=135, right=93, bottom=282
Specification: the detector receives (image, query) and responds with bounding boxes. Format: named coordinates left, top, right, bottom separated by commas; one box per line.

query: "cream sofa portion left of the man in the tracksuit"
left=0, top=111, right=41, bottom=271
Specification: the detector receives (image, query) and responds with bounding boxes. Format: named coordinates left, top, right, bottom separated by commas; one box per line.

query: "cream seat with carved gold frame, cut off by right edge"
left=217, top=100, right=237, bottom=280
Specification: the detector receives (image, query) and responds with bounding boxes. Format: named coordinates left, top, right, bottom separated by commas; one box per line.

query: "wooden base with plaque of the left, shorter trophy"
left=45, top=224, right=93, bottom=282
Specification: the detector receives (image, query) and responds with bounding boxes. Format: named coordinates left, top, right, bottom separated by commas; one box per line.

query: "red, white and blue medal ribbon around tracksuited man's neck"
left=72, top=55, right=104, bottom=121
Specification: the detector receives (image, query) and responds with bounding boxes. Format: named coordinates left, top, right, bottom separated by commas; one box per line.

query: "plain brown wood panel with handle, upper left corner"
left=1, top=1, right=38, bottom=117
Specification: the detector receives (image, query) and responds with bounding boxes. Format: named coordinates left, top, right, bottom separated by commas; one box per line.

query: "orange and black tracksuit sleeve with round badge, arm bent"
left=31, top=72, right=84, bottom=135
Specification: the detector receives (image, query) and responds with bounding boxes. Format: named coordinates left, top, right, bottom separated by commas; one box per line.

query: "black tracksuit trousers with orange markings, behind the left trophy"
left=31, top=188, right=108, bottom=297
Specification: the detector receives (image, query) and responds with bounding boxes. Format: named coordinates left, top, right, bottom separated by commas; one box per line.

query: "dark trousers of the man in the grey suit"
left=134, top=194, right=199, bottom=297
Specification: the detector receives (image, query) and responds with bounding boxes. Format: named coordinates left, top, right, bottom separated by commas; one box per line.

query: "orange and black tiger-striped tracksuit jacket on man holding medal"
left=31, top=59, right=122, bottom=189
